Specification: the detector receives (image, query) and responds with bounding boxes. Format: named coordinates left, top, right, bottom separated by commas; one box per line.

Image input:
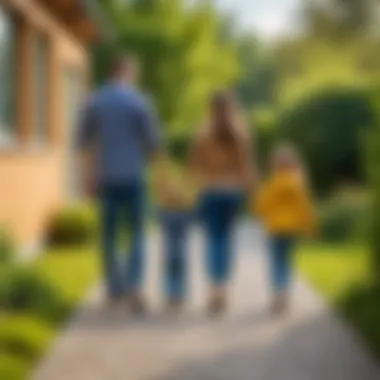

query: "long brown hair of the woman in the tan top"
left=210, top=91, right=243, bottom=147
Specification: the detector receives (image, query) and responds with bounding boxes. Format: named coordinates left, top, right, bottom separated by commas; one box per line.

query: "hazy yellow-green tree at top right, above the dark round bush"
left=274, top=0, right=380, bottom=105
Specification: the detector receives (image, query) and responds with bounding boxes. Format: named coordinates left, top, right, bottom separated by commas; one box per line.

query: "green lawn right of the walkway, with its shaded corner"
left=296, top=243, right=380, bottom=359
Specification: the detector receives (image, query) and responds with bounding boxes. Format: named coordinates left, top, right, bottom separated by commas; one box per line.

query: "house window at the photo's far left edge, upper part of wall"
left=0, top=7, right=16, bottom=148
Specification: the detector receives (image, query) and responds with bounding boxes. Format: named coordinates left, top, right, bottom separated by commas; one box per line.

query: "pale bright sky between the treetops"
left=217, top=0, right=302, bottom=39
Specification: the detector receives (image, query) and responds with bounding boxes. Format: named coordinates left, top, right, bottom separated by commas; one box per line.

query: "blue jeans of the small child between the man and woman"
left=160, top=210, right=190, bottom=300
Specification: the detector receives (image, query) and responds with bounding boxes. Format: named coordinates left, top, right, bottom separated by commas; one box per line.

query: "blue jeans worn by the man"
left=100, top=181, right=145, bottom=297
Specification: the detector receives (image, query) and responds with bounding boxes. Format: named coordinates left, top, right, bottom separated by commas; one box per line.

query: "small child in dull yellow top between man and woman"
left=158, top=161, right=194, bottom=312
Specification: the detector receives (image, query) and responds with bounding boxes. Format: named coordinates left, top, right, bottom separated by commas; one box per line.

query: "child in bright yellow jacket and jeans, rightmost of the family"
left=254, top=145, right=315, bottom=313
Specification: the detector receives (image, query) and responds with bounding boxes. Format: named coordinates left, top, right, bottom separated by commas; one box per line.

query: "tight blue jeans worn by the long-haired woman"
left=199, top=190, right=242, bottom=285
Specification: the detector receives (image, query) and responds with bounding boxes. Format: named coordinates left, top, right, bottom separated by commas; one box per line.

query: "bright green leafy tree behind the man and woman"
left=95, top=0, right=239, bottom=133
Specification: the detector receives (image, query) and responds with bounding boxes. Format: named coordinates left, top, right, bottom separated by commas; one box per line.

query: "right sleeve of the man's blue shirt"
left=137, top=95, right=162, bottom=154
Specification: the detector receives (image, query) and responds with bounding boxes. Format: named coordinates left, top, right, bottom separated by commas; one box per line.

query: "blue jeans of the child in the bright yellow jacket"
left=269, top=236, right=294, bottom=292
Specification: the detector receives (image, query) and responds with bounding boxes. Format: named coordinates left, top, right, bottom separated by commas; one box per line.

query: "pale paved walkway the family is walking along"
left=33, top=226, right=380, bottom=380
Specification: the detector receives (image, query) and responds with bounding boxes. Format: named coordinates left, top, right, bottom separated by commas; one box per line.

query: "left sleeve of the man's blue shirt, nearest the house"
left=76, top=100, right=96, bottom=150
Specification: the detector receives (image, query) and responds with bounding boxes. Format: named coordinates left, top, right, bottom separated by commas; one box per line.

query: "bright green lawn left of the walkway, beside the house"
left=0, top=247, right=99, bottom=380
